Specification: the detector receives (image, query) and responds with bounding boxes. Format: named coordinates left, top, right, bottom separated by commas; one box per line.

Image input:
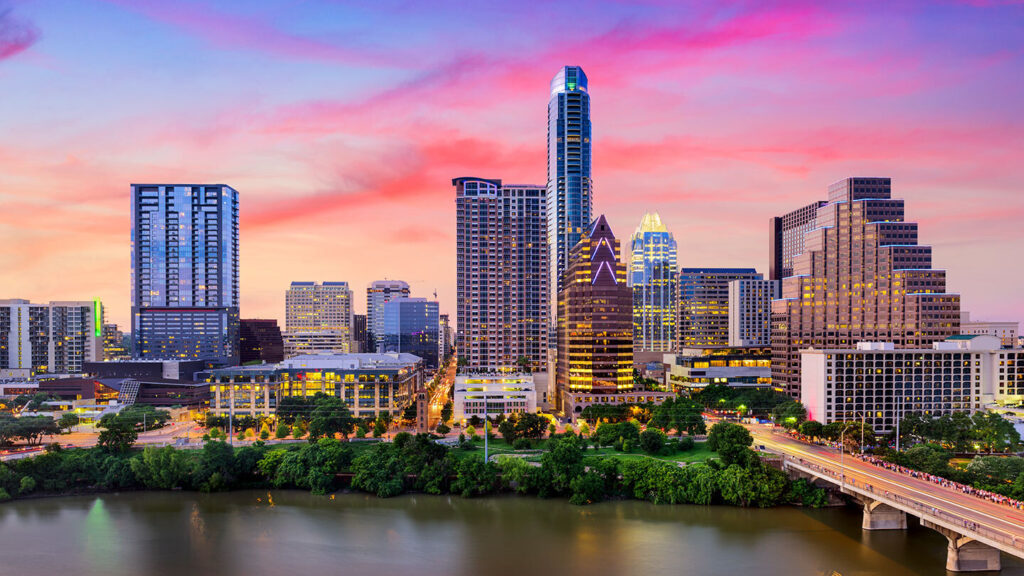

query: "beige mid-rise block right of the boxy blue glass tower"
left=285, top=282, right=352, bottom=357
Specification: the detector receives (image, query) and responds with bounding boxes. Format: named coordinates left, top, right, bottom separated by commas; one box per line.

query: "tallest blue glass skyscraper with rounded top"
left=547, top=66, right=593, bottom=330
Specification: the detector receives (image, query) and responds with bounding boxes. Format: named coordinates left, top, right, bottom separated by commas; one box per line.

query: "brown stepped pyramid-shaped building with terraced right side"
left=772, top=177, right=959, bottom=397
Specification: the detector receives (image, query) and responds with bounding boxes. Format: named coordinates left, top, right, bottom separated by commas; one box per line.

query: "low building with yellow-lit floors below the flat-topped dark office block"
left=664, top=346, right=771, bottom=393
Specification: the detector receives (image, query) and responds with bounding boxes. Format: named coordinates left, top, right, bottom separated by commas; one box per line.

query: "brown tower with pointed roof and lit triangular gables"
left=555, top=215, right=633, bottom=418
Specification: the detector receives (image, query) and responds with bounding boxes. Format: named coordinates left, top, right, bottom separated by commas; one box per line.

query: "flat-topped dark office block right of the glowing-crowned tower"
left=676, top=268, right=761, bottom=349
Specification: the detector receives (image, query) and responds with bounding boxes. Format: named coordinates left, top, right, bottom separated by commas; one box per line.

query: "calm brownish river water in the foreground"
left=0, top=491, right=1024, bottom=576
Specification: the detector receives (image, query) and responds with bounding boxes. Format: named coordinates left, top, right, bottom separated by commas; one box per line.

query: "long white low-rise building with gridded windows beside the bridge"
left=800, top=335, right=1024, bottom=434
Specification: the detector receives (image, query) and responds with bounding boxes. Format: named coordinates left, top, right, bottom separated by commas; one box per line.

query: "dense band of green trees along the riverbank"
left=0, top=416, right=824, bottom=506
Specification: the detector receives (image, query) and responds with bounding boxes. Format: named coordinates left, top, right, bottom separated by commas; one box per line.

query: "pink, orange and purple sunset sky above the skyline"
left=0, top=0, right=1024, bottom=327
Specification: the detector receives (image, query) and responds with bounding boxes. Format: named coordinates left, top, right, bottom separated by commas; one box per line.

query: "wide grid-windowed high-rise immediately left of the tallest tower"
left=452, top=177, right=550, bottom=372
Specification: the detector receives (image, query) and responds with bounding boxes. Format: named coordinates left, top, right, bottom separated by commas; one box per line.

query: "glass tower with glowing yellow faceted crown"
left=629, top=212, right=676, bottom=352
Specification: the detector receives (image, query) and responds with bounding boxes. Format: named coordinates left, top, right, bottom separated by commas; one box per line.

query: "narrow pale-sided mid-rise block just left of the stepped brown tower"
left=729, top=280, right=782, bottom=346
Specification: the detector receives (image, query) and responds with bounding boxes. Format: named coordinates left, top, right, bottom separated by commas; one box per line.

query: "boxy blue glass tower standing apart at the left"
left=131, top=184, right=239, bottom=362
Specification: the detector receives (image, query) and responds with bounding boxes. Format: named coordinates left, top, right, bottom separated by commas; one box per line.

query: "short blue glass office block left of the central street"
left=378, top=297, right=440, bottom=370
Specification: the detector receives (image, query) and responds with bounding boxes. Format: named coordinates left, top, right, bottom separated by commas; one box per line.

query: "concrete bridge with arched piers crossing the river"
left=751, top=427, right=1024, bottom=572
